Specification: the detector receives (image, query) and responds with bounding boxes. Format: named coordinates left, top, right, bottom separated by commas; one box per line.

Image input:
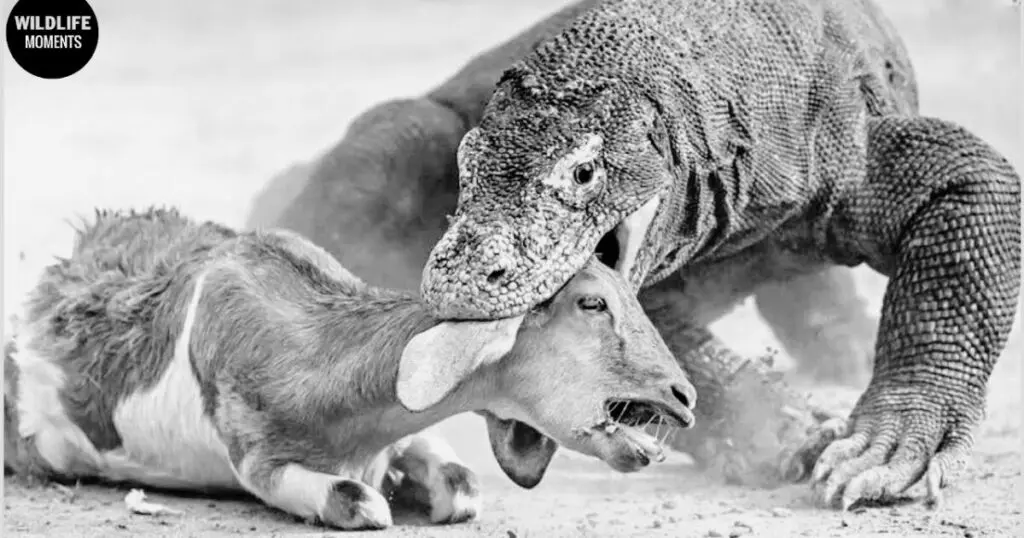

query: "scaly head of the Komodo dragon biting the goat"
left=421, top=67, right=673, bottom=319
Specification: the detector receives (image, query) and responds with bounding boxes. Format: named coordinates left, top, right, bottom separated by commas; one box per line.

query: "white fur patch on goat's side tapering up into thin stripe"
left=103, top=276, right=239, bottom=489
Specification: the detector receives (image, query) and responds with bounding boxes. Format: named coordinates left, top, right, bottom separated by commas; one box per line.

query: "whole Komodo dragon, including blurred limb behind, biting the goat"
left=243, top=0, right=1020, bottom=505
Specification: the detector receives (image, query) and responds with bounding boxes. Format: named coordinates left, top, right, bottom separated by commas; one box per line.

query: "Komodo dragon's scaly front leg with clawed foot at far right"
left=793, top=118, right=1021, bottom=507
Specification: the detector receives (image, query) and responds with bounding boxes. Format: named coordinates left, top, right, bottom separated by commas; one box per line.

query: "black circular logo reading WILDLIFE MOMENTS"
left=7, top=0, right=99, bottom=79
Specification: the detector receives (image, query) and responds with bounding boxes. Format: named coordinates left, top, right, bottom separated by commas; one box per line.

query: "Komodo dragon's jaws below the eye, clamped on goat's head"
left=422, top=191, right=660, bottom=319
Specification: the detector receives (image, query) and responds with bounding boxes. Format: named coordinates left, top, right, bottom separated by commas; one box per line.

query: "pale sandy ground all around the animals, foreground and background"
left=3, top=0, right=1024, bottom=538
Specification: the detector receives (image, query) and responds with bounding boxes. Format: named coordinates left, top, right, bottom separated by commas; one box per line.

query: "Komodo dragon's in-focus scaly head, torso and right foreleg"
left=422, top=0, right=1021, bottom=507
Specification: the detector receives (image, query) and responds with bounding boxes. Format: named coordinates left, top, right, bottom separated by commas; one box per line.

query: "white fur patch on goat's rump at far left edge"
left=11, top=325, right=100, bottom=474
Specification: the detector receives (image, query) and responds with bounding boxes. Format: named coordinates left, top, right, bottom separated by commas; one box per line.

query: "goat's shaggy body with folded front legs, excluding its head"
left=4, top=210, right=478, bottom=528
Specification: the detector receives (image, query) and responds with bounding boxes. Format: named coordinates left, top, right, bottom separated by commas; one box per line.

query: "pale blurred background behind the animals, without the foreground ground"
left=2, top=0, right=1024, bottom=532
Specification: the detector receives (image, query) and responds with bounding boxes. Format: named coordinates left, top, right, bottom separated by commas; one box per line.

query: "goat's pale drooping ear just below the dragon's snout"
left=395, top=316, right=523, bottom=412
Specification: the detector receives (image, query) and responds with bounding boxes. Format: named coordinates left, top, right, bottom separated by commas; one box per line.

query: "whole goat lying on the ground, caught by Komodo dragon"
left=4, top=209, right=696, bottom=529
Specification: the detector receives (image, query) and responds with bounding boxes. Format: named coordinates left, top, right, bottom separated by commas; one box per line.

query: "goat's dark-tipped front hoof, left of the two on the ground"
left=319, top=480, right=392, bottom=530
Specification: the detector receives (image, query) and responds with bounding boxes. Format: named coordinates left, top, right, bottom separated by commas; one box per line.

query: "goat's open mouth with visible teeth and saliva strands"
left=599, top=398, right=686, bottom=465
